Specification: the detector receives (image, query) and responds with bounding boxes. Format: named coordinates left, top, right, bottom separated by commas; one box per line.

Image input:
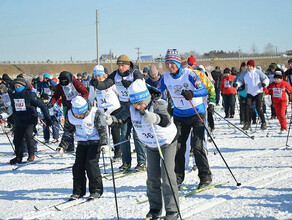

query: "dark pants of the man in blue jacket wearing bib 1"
left=174, top=113, right=212, bottom=184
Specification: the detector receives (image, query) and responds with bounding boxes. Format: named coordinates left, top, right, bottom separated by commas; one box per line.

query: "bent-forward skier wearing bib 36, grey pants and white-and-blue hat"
left=101, top=79, right=178, bottom=219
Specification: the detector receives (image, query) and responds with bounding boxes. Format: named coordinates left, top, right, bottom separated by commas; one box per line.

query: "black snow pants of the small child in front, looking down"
left=73, top=143, right=103, bottom=195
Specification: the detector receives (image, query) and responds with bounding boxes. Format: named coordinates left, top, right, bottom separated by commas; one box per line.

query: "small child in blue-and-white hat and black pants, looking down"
left=57, top=96, right=107, bottom=200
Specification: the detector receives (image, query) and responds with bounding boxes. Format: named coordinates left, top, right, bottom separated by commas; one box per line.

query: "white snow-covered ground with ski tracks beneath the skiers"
left=0, top=107, right=292, bottom=219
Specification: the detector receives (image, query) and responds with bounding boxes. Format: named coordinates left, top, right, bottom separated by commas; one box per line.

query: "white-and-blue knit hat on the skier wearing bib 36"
left=128, top=79, right=151, bottom=103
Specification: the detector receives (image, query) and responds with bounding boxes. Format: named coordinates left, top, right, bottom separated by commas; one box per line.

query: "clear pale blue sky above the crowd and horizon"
left=0, top=0, right=292, bottom=61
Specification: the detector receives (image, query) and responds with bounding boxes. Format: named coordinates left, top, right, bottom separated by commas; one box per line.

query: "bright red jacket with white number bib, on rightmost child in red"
left=265, top=80, right=292, bottom=103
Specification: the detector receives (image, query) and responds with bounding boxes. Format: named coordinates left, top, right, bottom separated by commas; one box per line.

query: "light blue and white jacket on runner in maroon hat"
left=236, top=69, right=269, bottom=96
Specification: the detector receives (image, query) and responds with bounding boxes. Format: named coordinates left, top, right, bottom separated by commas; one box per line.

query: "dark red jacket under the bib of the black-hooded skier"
left=50, top=75, right=89, bottom=111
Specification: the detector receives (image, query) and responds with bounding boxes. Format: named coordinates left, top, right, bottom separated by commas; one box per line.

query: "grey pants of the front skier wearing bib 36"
left=146, top=140, right=178, bottom=212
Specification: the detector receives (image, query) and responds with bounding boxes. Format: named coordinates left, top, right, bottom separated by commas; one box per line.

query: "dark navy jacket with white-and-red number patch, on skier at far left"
left=10, top=82, right=51, bottom=126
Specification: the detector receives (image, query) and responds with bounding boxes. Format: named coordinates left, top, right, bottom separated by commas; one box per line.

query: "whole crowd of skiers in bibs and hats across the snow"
left=0, top=49, right=292, bottom=219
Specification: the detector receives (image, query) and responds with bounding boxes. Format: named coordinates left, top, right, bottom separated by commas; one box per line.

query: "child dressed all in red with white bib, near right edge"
left=265, top=71, right=292, bottom=134
